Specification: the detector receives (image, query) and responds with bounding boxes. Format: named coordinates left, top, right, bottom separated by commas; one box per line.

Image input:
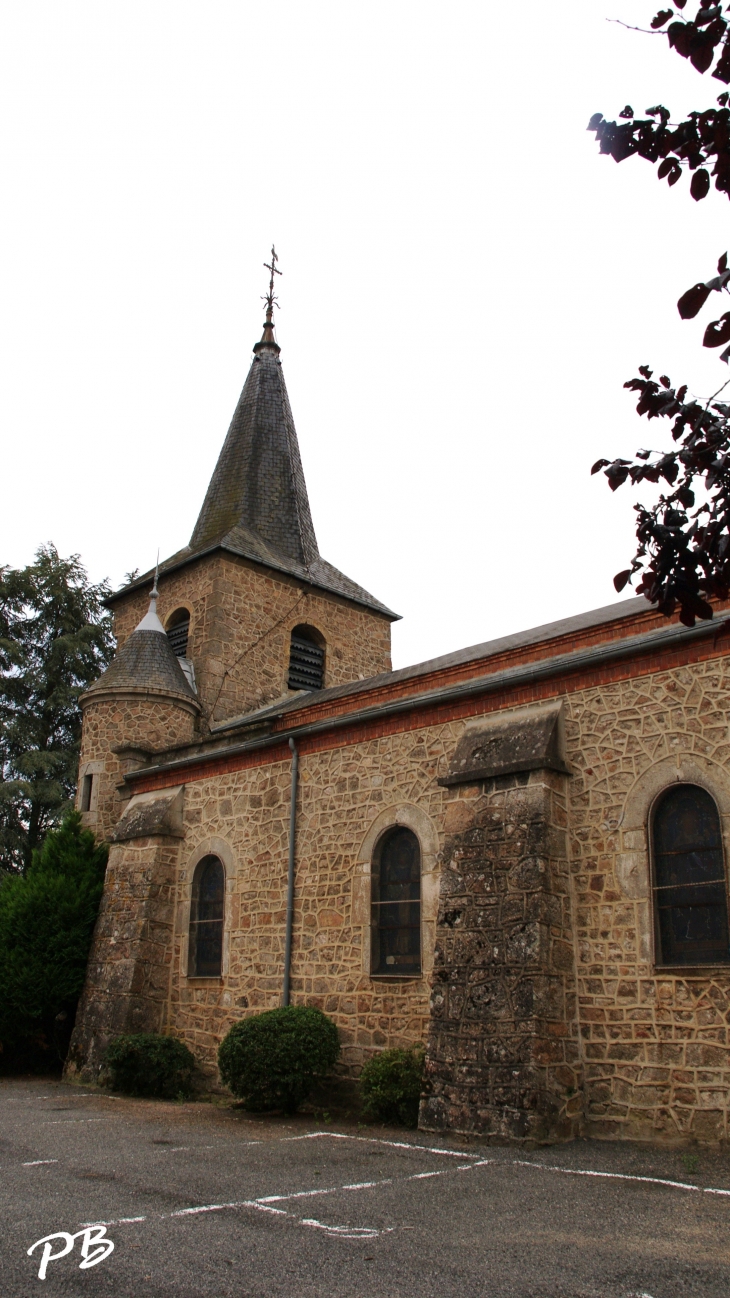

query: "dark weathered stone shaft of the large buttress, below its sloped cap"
left=420, top=771, right=582, bottom=1140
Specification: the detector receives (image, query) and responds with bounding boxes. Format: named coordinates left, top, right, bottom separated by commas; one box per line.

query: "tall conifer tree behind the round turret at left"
left=0, top=545, right=113, bottom=871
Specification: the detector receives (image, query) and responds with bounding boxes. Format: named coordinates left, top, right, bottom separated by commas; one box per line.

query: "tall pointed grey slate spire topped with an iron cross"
left=190, top=248, right=320, bottom=567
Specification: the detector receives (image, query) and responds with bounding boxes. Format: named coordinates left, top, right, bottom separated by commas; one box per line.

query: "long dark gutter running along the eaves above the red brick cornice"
left=125, top=614, right=730, bottom=784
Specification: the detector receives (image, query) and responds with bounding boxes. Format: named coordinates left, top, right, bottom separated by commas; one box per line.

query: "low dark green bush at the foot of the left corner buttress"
left=104, top=1032, right=195, bottom=1099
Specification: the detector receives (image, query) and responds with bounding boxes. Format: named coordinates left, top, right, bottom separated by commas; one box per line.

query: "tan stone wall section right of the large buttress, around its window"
left=566, top=657, right=730, bottom=1140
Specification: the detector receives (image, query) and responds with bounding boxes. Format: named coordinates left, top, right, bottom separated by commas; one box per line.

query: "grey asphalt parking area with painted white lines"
left=0, top=1079, right=730, bottom=1298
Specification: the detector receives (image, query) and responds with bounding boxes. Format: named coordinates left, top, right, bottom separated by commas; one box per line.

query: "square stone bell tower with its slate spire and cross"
left=103, top=249, right=397, bottom=735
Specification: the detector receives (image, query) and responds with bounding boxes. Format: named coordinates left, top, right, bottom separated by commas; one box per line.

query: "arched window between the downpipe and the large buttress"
left=370, top=826, right=421, bottom=975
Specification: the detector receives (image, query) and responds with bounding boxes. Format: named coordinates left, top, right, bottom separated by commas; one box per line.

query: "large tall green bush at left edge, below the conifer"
left=0, top=811, right=108, bottom=1072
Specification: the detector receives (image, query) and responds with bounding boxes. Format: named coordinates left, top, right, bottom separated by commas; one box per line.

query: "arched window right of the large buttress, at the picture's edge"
left=653, top=784, right=730, bottom=964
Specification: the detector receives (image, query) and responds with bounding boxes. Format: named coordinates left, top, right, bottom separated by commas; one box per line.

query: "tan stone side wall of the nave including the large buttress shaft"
left=71, top=643, right=730, bottom=1140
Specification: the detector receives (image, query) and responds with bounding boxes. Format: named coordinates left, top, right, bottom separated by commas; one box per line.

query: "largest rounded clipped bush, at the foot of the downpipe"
left=218, top=1005, right=339, bottom=1114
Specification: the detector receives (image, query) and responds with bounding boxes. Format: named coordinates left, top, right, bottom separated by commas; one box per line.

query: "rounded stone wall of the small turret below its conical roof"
left=77, top=693, right=197, bottom=840
